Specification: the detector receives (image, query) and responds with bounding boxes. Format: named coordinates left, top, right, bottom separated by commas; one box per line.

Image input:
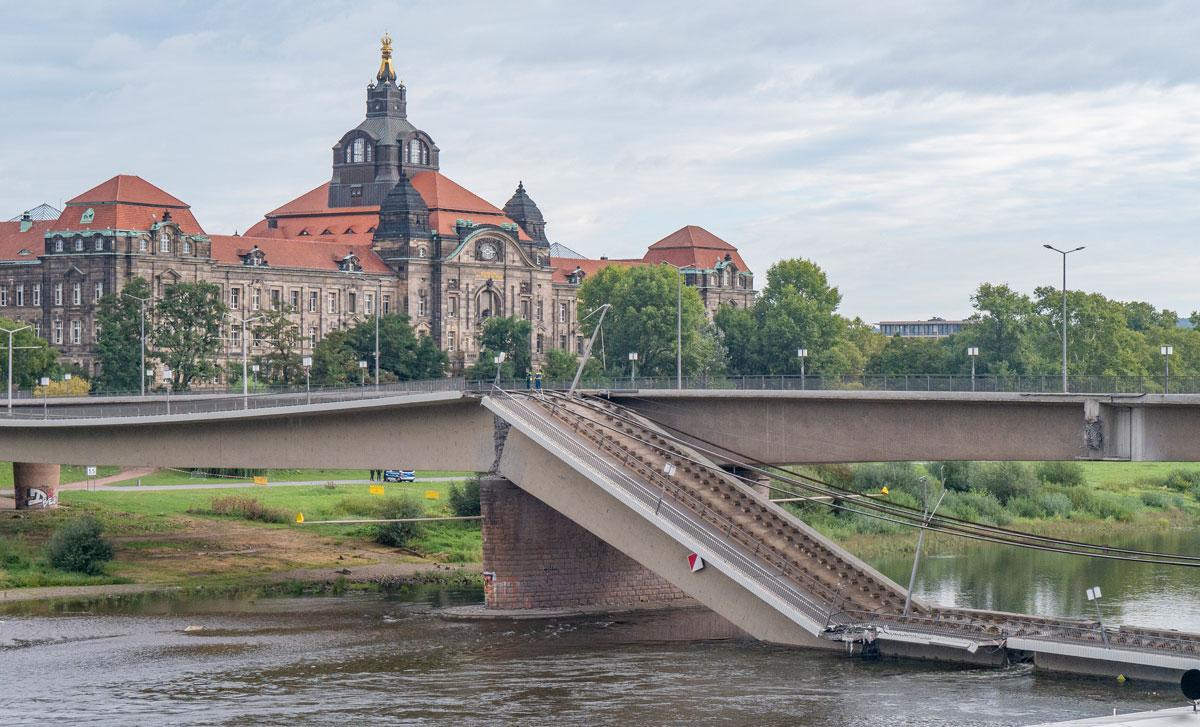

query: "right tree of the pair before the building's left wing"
left=154, top=282, right=227, bottom=389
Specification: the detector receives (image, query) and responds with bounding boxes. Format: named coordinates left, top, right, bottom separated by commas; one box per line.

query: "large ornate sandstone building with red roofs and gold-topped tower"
left=0, top=37, right=755, bottom=379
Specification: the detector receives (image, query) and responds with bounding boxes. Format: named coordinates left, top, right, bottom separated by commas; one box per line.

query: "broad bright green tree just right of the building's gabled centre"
left=578, top=265, right=705, bottom=377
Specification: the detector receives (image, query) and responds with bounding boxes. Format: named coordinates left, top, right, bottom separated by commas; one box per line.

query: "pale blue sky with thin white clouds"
left=0, top=0, right=1200, bottom=322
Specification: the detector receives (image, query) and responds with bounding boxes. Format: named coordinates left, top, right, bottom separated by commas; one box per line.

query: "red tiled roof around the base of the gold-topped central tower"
left=246, top=172, right=529, bottom=242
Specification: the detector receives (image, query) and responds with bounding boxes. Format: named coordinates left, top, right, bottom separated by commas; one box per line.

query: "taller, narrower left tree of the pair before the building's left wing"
left=96, top=277, right=154, bottom=391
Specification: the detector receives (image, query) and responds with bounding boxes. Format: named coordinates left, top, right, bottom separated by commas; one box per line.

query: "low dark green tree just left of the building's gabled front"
left=347, top=314, right=450, bottom=381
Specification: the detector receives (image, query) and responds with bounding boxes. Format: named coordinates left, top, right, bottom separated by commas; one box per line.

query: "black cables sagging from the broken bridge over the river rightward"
left=540, top=393, right=1200, bottom=567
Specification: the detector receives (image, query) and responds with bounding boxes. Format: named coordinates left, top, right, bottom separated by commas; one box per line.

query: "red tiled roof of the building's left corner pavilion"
left=54, top=174, right=204, bottom=235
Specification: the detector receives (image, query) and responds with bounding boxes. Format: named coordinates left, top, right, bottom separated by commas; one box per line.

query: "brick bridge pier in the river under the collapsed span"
left=479, top=477, right=691, bottom=609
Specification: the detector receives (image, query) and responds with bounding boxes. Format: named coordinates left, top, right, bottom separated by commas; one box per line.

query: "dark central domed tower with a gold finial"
left=329, top=35, right=438, bottom=208
